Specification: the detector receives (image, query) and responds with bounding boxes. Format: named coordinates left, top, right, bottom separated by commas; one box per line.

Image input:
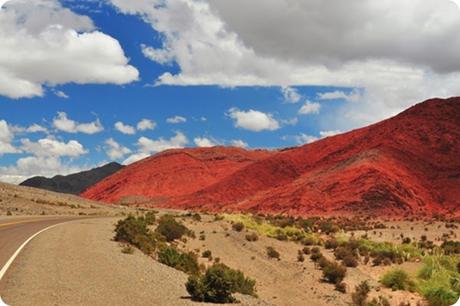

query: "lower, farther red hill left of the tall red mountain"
left=82, top=147, right=273, bottom=203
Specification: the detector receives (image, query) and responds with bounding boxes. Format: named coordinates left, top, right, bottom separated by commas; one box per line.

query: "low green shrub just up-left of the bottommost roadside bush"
left=158, top=247, right=200, bottom=274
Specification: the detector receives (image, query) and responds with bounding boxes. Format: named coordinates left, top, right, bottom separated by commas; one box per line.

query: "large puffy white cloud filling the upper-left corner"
left=0, top=0, right=139, bottom=98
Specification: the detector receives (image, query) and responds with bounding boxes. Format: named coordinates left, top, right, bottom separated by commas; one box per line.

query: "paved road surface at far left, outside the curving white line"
left=0, top=216, right=81, bottom=278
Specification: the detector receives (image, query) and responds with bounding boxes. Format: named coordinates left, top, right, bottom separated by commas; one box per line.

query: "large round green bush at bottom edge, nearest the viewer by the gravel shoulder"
left=185, top=264, right=256, bottom=303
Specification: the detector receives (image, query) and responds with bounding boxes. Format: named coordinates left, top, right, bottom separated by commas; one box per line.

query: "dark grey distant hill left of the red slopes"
left=19, top=162, right=124, bottom=195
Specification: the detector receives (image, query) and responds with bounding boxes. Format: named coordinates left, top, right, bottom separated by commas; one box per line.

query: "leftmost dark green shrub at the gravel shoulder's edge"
left=114, top=215, right=158, bottom=254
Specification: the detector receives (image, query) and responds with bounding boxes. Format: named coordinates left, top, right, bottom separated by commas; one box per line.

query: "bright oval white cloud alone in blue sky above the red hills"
left=228, top=108, right=280, bottom=132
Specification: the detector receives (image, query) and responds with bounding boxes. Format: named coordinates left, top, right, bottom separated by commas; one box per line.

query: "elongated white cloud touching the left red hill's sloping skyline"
left=123, top=132, right=188, bottom=165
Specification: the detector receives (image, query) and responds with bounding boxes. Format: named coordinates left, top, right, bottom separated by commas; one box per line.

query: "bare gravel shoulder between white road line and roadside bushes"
left=0, top=218, right=267, bottom=306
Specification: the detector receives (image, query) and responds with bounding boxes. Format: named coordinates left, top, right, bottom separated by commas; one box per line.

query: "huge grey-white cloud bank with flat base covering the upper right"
left=111, top=0, right=460, bottom=129
